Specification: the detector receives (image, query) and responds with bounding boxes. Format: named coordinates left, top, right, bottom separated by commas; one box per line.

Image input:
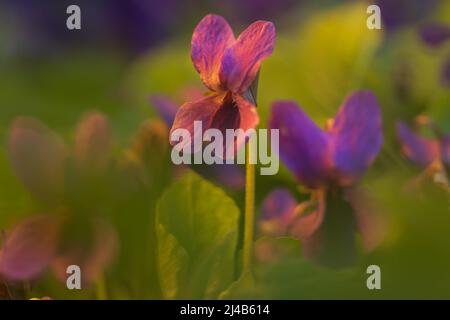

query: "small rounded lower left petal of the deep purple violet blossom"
left=258, top=188, right=297, bottom=236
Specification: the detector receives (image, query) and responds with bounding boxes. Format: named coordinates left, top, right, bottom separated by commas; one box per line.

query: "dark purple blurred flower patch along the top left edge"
left=2, top=0, right=179, bottom=55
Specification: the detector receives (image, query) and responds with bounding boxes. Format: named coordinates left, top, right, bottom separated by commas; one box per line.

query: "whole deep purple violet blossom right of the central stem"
left=266, top=91, right=383, bottom=262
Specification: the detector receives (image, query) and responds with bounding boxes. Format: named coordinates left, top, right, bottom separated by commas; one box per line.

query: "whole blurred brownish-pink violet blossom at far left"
left=0, top=113, right=117, bottom=283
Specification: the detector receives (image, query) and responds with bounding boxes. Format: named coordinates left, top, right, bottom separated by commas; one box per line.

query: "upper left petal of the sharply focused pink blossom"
left=191, top=14, right=234, bottom=91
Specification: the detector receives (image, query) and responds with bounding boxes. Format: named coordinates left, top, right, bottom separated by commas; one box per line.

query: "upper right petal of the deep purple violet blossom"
left=330, top=91, right=383, bottom=185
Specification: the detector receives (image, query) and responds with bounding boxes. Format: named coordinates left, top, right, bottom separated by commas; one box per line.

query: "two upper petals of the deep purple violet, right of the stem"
left=270, top=91, right=383, bottom=189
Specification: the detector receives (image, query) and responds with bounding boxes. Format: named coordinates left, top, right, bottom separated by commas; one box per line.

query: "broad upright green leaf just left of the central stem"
left=156, top=174, right=239, bottom=299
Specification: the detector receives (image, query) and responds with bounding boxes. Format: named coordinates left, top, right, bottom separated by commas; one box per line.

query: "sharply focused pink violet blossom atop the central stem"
left=170, top=15, right=275, bottom=151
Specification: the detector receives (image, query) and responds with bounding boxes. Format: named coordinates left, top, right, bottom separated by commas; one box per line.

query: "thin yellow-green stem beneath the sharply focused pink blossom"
left=242, top=143, right=255, bottom=274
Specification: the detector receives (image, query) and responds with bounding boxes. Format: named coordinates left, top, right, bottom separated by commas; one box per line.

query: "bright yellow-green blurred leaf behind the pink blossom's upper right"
left=258, top=3, right=382, bottom=125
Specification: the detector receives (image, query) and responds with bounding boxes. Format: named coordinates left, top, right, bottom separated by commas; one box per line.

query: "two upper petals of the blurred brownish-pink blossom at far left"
left=8, top=112, right=112, bottom=203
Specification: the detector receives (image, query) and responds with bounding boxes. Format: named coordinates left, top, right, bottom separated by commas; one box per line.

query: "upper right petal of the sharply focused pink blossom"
left=220, top=21, right=275, bottom=93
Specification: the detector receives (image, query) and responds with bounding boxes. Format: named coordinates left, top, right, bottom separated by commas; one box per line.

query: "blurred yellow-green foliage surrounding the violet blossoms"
left=0, top=1, right=450, bottom=299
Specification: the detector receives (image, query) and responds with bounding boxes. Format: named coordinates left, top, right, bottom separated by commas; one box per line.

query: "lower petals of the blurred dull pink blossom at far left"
left=0, top=215, right=117, bottom=284
